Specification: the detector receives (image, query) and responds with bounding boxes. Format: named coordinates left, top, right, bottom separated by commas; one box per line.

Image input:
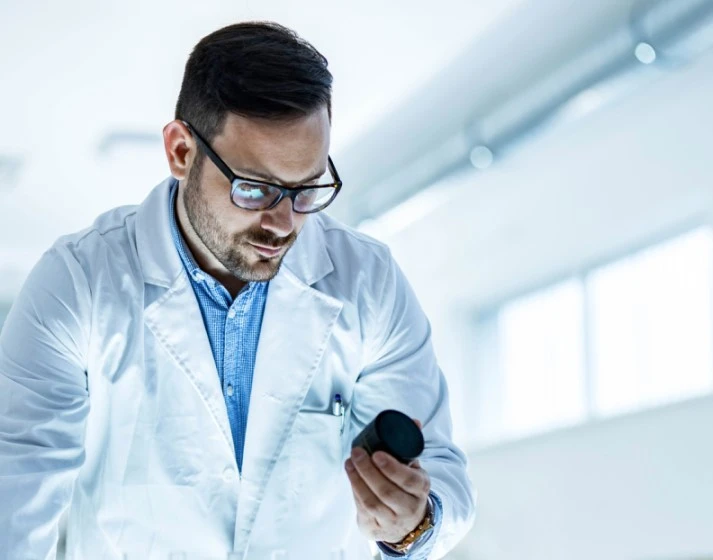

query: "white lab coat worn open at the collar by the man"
left=0, top=180, right=474, bottom=560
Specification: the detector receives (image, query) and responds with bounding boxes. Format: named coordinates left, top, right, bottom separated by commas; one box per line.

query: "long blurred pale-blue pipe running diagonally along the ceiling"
left=343, top=0, right=713, bottom=230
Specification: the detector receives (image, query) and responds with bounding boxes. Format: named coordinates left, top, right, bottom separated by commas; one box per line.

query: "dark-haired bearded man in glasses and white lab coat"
left=0, top=23, right=473, bottom=560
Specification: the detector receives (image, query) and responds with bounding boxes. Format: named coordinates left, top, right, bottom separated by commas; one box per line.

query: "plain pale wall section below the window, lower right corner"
left=449, top=397, right=713, bottom=560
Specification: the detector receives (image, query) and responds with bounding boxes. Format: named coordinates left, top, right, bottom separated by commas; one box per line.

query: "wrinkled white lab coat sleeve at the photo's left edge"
left=0, top=246, right=91, bottom=560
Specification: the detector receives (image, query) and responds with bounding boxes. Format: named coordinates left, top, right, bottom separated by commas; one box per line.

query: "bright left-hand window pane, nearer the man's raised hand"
left=468, top=279, right=586, bottom=446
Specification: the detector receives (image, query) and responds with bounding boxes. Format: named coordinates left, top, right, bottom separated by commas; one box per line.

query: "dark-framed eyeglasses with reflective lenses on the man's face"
left=182, top=121, right=342, bottom=214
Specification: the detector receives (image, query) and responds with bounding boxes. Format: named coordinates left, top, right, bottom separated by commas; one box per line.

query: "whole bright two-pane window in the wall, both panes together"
left=472, top=227, right=713, bottom=445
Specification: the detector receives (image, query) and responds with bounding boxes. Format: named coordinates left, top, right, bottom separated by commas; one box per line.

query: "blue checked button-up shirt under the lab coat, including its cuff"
left=169, top=181, right=443, bottom=560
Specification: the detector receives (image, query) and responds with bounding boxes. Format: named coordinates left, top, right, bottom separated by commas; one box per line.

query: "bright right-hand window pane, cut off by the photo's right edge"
left=587, top=229, right=713, bottom=415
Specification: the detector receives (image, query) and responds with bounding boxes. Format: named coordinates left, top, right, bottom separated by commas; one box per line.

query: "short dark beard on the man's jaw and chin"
left=183, top=156, right=297, bottom=282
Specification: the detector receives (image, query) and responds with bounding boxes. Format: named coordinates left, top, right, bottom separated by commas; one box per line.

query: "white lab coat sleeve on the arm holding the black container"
left=350, top=252, right=475, bottom=558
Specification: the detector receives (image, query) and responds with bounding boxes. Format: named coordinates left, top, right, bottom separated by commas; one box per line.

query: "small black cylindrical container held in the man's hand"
left=352, top=410, right=423, bottom=465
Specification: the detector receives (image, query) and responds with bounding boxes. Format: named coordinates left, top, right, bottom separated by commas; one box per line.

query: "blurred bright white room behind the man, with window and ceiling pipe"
left=0, top=0, right=713, bottom=560
